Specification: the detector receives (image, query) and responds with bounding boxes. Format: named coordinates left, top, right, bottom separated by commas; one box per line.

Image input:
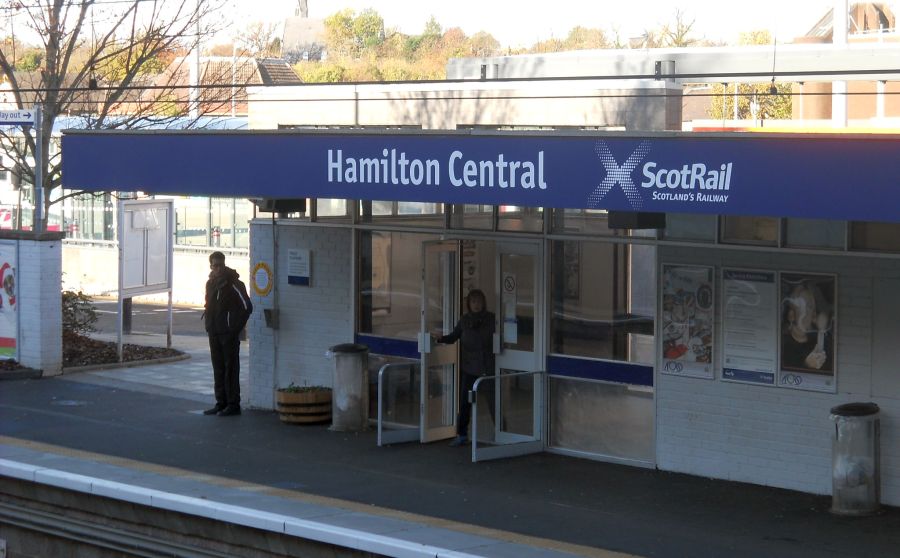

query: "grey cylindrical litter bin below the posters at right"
left=831, top=403, right=881, bottom=515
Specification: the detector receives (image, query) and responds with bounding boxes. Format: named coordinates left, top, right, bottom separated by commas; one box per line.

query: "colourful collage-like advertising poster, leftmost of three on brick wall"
left=662, top=265, right=715, bottom=378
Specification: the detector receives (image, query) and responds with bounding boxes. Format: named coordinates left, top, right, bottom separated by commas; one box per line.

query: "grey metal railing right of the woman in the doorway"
left=469, top=370, right=545, bottom=463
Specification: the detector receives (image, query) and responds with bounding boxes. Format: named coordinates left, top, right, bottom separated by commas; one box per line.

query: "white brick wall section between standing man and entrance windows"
left=247, top=222, right=354, bottom=409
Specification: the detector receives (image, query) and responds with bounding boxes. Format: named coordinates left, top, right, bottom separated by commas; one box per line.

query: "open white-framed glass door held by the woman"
left=419, top=241, right=460, bottom=443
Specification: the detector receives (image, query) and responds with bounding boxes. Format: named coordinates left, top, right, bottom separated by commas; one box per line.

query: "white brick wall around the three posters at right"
left=656, top=247, right=900, bottom=505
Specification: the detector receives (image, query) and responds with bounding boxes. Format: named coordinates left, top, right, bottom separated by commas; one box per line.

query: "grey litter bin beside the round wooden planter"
left=328, top=343, right=369, bottom=431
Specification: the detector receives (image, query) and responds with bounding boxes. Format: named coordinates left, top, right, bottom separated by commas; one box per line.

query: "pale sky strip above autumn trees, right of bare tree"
left=234, top=0, right=835, bottom=47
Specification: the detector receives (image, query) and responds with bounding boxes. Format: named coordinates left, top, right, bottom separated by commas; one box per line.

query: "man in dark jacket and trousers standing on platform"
left=203, top=252, right=253, bottom=417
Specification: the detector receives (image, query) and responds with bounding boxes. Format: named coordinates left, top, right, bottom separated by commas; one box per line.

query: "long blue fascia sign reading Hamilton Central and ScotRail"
left=62, top=131, right=900, bottom=222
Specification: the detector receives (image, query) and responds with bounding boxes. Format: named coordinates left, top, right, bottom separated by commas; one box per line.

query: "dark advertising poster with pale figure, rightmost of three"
left=778, top=273, right=837, bottom=392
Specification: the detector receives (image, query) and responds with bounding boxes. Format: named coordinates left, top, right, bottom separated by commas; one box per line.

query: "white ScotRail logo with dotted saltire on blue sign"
left=588, top=140, right=733, bottom=211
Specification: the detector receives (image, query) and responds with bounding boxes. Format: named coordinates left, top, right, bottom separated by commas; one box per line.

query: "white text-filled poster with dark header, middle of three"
left=722, top=269, right=778, bottom=385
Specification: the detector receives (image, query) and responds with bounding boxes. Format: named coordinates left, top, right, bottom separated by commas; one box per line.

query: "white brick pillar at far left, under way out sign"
left=16, top=240, right=62, bottom=376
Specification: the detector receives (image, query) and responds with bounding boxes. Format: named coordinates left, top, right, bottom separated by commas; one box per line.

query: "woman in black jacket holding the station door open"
left=437, top=289, right=496, bottom=446
